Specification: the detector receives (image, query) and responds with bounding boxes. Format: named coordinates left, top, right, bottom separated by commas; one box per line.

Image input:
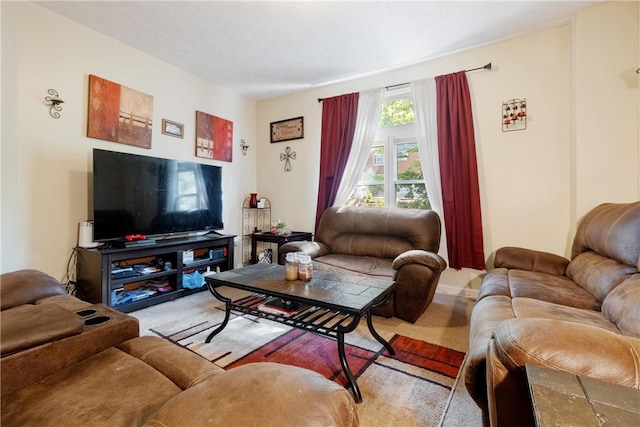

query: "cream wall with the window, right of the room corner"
left=256, top=2, right=640, bottom=295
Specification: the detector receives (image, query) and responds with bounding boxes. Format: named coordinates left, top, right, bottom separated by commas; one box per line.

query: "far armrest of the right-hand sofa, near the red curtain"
left=494, top=246, right=569, bottom=276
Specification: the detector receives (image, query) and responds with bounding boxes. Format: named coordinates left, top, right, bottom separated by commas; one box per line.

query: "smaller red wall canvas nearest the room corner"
left=196, top=111, right=233, bottom=162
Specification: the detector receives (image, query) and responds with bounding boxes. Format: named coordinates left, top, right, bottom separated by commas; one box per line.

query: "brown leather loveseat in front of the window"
left=280, top=207, right=447, bottom=322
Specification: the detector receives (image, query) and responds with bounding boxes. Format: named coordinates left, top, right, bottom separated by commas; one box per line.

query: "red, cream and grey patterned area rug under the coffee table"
left=152, top=310, right=465, bottom=426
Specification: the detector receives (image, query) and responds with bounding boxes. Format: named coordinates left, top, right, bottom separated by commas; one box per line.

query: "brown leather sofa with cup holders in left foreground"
left=0, top=270, right=358, bottom=427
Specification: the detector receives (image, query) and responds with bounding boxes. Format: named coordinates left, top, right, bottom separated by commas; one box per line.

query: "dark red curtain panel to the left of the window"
left=315, top=93, right=359, bottom=229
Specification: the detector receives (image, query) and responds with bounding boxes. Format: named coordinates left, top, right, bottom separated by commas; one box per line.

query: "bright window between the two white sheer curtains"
left=351, top=91, right=431, bottom=209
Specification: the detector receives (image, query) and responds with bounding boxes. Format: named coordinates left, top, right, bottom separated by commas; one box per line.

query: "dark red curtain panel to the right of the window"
left=436, top=71, right=485, bottom=270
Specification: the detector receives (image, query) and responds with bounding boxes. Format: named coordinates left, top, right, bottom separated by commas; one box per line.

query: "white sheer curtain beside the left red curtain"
left=333, top=88, right=384, bottom=206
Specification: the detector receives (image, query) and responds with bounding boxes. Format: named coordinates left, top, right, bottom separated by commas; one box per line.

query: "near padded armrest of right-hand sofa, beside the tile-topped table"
left=493, top=319, right=640, bottom=389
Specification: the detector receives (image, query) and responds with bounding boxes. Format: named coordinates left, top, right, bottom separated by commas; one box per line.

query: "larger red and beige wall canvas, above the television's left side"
left=87, top=75, right=153, bottom=148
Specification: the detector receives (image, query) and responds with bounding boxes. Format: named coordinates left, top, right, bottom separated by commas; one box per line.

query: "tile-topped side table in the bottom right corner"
left=525, top=364, right=640, bottom=427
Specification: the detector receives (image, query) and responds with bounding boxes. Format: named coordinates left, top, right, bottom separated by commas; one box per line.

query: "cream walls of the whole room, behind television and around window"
left=0, top=2, right=640, bottom=294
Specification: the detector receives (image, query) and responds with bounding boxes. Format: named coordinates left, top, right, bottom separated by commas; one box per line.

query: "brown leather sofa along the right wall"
left=465, top=202, right=640, bottom=426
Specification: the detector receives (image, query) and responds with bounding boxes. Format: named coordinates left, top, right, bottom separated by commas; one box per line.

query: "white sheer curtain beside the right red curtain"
left=411, top=77, right=449, bottom=264
